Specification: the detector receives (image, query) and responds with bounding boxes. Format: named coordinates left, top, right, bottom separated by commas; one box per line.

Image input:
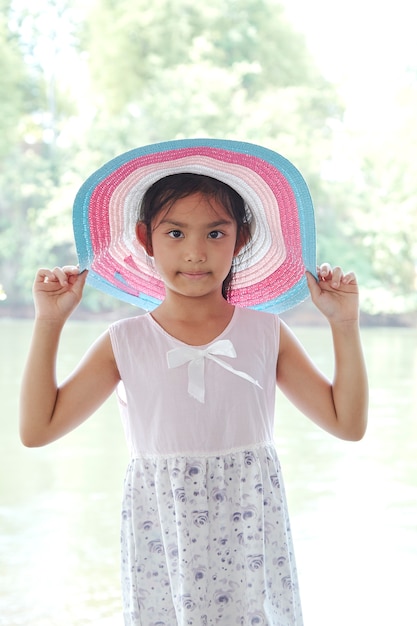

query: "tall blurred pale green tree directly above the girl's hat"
left=82, top=0, right=342, bottom=185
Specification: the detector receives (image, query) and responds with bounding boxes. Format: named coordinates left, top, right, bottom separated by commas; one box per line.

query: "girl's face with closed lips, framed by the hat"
left=137, top=193, right=245, bottom=297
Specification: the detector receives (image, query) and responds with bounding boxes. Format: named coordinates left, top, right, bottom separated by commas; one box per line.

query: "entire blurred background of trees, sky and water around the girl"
left=0, top=0, right=417, bottom=626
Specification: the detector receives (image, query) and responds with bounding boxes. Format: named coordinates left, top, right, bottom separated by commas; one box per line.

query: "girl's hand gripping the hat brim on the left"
left=33, top=265, right=88, bottom=322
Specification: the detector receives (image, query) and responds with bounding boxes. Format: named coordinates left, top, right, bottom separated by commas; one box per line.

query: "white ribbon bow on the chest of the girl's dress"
left=167, top=339, right=262, bottom=403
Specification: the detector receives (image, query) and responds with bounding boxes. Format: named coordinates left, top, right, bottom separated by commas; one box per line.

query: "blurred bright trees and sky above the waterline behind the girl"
left=0, top=0, right=417, bottom=315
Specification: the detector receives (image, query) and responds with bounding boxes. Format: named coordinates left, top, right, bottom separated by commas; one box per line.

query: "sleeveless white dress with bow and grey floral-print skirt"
left=110, top=308, right=302, bottom=626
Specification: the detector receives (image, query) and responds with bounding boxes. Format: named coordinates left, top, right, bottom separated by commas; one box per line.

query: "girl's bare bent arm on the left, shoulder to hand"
left=20, top=266, right=120, bottom=447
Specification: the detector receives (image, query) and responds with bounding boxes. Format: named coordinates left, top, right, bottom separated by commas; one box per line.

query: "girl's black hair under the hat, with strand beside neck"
left=138, top=172, right=251, bottom=300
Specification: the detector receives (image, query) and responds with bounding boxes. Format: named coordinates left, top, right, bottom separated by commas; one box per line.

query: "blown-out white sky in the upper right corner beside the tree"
left=282, top=0, right=417, bottom=125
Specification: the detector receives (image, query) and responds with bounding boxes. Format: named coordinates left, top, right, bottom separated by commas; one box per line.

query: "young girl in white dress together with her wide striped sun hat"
left=21, top=140, right=367, bottom=626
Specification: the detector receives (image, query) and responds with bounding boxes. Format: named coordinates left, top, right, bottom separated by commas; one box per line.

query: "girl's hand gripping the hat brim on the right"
left=306, top=263, right=359, bottom=323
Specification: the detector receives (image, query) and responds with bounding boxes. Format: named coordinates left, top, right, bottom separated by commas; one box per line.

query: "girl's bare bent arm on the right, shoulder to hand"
left=277, top=264, right=368, bottom=441
